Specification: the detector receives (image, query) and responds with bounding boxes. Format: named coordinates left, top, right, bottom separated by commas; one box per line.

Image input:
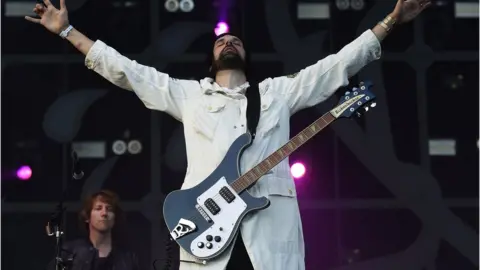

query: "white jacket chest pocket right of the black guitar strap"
left=257, top=95, right=280, bottom=137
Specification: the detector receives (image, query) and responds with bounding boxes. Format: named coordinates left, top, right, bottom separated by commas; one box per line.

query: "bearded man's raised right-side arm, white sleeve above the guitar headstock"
left=270, top=0, right=430, bottom=114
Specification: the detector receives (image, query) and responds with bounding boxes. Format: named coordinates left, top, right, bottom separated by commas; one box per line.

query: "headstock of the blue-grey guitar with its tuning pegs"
left=330, top=82, right=376, bottom=118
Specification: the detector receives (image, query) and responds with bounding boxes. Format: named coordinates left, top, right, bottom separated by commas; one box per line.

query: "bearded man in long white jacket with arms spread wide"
left=26, top=0, right=430, bottom=270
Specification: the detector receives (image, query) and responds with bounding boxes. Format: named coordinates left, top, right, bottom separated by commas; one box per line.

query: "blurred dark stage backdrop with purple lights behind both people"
left=1, top=0, right=479, bottom=270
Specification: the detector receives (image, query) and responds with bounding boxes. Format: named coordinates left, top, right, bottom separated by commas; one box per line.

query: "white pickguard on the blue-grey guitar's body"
left=190, top=177, right=247, bottom=258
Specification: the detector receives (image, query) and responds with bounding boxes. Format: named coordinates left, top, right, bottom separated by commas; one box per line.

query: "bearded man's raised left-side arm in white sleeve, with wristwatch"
left=25, top=0, right=200, bottom=120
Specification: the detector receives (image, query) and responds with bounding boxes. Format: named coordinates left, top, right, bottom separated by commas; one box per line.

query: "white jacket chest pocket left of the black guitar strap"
left=193, top=99, right=226, bottom=141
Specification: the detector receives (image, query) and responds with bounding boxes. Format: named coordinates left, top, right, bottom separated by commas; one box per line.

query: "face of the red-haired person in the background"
left=87, top=198, right=115, bottom=233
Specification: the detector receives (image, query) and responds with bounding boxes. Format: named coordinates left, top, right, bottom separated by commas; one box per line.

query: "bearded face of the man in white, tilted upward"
left=212, top=35, right=245, bottom=72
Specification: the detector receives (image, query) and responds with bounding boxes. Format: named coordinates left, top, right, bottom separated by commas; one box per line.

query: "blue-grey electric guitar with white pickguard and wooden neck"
left=163, top=80, right=375, bottom=263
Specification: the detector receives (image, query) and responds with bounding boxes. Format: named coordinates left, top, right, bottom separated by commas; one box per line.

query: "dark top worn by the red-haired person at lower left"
left=48, top=239, right=141, bottom=270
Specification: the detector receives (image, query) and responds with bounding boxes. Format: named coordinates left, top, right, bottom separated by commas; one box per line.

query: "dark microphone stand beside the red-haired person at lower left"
left=45, top=151, right=83, bottom=270
